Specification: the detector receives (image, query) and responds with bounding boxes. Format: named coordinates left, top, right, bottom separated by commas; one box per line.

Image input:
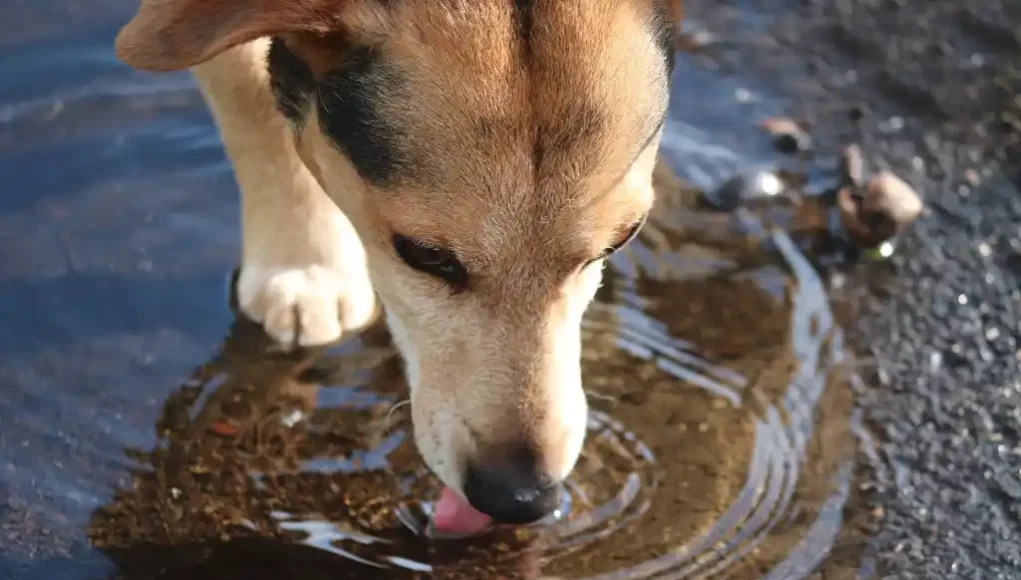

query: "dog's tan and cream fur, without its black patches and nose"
left=118, top=0, right=679, bottom=498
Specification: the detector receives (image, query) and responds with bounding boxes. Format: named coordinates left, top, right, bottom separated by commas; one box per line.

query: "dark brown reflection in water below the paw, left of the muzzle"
left=88, top=321, right=537, bottom=580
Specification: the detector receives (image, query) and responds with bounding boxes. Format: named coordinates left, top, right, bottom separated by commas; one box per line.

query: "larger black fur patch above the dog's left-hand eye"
left=317, top=46, right=408, bottom=185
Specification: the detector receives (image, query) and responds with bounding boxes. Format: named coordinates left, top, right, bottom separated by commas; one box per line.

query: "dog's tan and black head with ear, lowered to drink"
left=117, top=0, right=679, bottom=522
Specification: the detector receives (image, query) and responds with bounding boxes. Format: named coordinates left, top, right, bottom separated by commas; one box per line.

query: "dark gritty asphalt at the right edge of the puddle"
left=710, top=0, right=1021, bottom=579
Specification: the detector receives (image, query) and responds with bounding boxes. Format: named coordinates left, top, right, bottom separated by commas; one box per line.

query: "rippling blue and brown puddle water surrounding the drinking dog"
left=0, top=2, right=864, bottom=580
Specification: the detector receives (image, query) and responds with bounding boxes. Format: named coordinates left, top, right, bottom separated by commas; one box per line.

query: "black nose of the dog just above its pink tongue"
left=464, top=462, right=561, bottom=524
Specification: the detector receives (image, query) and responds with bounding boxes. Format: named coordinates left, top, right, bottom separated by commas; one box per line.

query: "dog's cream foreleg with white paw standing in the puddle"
left=192, top=39, right=376, bottom=346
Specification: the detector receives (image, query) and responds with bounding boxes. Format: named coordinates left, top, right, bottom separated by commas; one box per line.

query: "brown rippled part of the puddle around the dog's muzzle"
left=71, top=195, right=857, bottom=580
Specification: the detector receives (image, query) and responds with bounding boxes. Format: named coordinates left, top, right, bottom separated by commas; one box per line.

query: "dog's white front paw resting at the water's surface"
left=236, top=264, right=376, bottom=348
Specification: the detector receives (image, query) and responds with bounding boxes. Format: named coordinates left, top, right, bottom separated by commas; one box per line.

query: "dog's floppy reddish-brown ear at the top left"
left=116, top=0, right=351, bottom=71
